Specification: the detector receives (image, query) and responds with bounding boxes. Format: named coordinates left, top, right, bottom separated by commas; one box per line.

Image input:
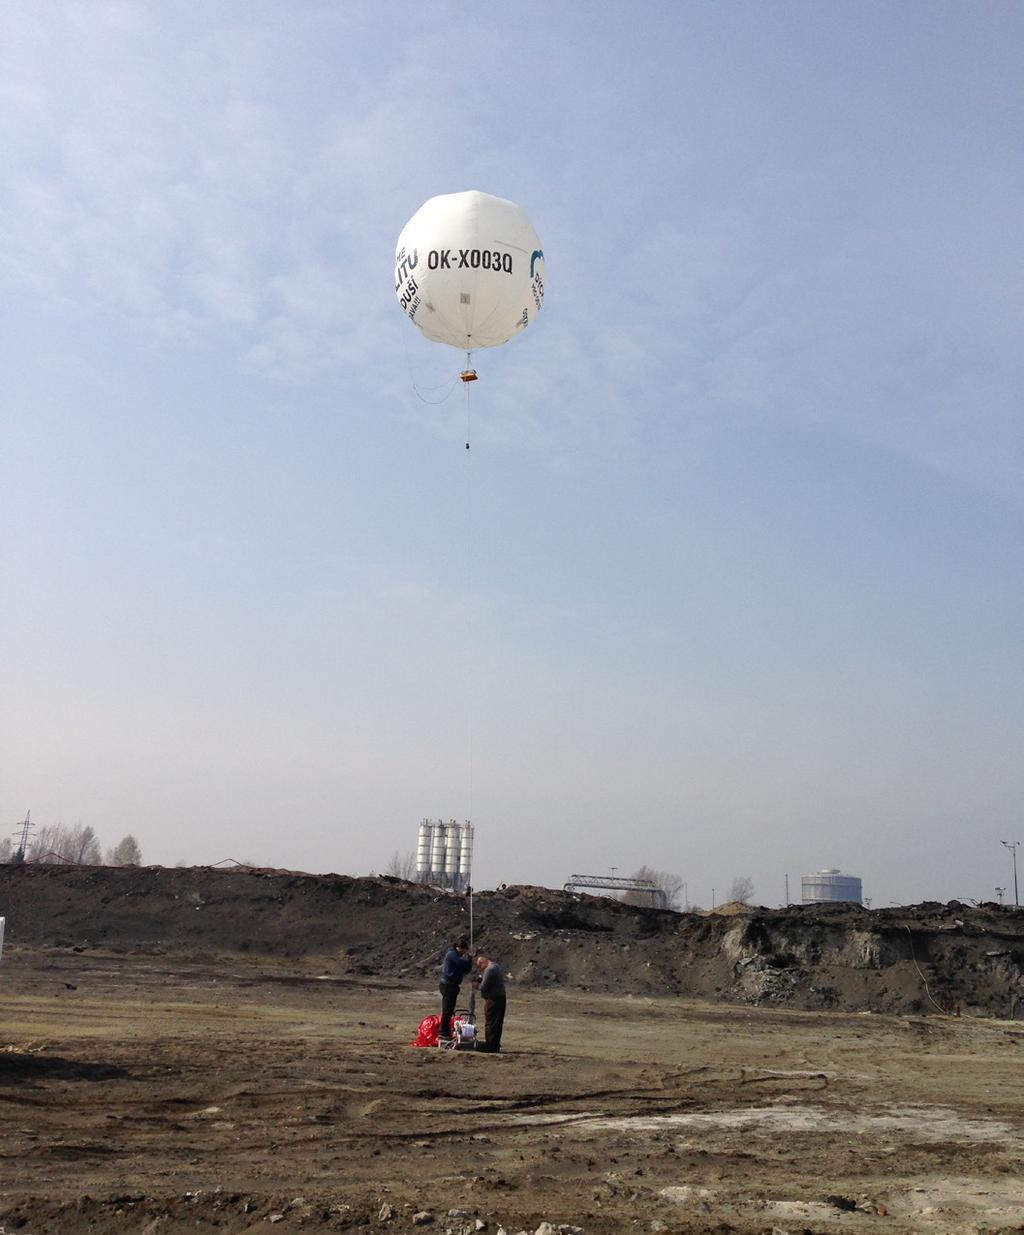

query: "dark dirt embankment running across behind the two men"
left=0, top=866, right=1024, bottom=1018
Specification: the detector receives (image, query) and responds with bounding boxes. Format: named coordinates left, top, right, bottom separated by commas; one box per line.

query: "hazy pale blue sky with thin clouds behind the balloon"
left=0, top=0, right=1024, bottom=905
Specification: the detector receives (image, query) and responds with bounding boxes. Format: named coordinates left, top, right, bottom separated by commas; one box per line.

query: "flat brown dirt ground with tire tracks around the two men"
left=0, top=945, right=1024, bottom=1235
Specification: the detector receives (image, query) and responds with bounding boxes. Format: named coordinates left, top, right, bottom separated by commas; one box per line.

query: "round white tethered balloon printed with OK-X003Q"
left=395, top=190, right=543, bottom=352
